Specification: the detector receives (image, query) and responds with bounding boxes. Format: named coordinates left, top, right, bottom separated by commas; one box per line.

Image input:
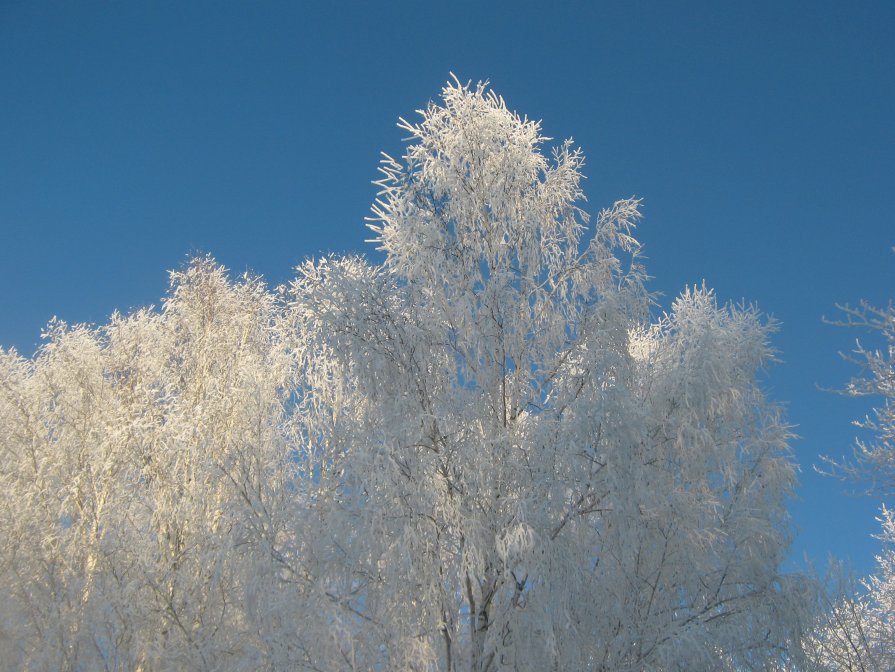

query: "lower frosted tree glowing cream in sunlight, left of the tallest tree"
left=0, top=259, right=326, bottom=671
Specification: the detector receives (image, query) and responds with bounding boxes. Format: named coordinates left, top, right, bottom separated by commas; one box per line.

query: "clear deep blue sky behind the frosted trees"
left=0, top=0, right=895, bottom=572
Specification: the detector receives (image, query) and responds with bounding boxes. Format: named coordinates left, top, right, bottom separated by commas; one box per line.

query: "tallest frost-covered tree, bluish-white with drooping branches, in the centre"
left=289, top=76, right=794, bottom=671
